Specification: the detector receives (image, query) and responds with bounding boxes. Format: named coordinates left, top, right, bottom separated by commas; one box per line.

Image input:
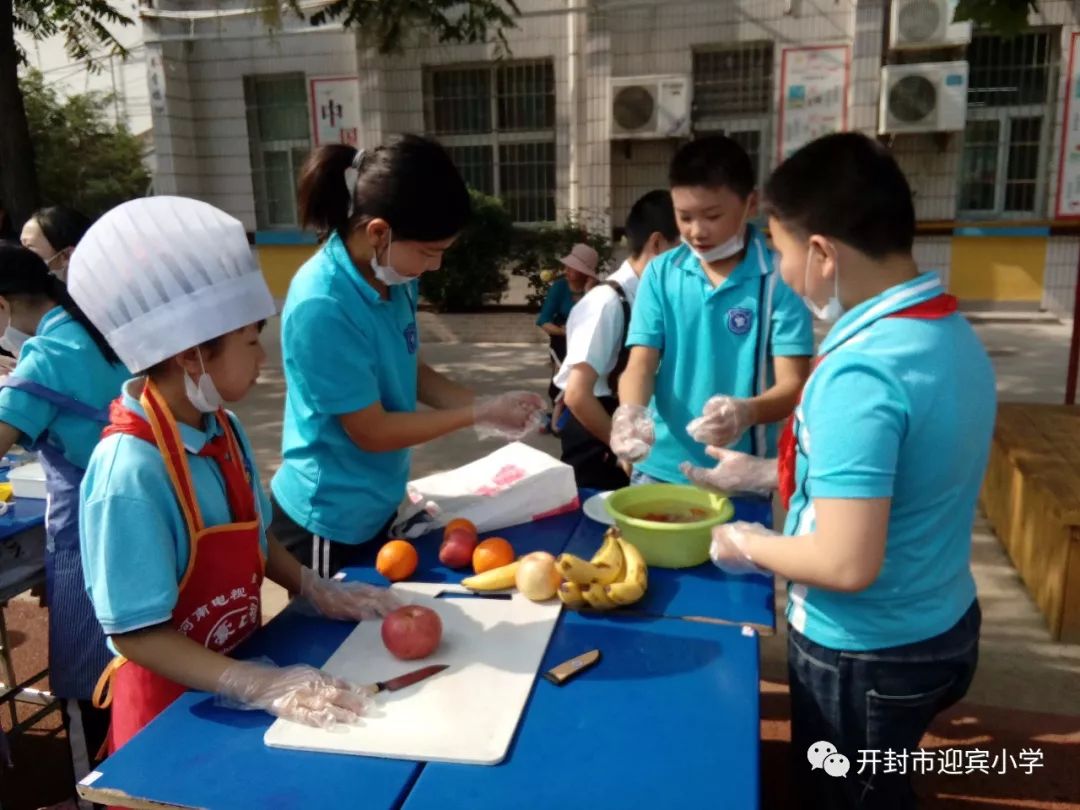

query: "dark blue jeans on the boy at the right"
left=787, top=600, right=982, bottom=810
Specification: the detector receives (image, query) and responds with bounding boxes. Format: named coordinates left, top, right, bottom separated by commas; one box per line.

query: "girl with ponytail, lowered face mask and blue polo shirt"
left=272, top=135, right=544, bottom=576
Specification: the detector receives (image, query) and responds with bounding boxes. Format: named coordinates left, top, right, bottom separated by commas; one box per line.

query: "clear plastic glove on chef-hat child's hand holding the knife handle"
left=217, top=661, right=374, bottom=728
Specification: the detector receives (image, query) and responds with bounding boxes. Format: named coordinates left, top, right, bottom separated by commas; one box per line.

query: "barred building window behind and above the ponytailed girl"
left=423, top=62, right=555, bottom=222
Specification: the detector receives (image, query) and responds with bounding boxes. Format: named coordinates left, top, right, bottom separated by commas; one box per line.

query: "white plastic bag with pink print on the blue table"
left=391, top=442, right=579, bottom=538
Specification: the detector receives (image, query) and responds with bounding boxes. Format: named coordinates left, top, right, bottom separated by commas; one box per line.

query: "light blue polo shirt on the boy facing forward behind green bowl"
left=626, top=226, right=813, bottom=483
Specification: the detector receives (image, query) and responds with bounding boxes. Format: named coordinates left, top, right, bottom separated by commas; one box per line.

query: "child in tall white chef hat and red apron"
left=68, top=197, right=395, bottom=751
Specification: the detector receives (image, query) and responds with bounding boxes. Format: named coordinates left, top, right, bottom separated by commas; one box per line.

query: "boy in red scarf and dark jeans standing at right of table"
left=685, top=133, right=996, bottom=808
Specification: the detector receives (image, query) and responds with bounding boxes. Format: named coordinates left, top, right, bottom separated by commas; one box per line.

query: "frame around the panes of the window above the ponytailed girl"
left=423, top=57, right=558, bottom=227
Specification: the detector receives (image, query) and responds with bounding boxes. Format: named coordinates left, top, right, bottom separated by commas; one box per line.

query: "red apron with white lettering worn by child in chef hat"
left=95, top=380, right=266, bottom=754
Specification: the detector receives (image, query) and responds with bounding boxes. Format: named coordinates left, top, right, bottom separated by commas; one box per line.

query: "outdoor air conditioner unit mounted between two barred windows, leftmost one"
left=609, top=76, right=690, bottom=140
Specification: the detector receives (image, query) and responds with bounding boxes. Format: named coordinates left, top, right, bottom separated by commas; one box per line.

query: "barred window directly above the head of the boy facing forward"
left=693, top=42, right=772, bottom=186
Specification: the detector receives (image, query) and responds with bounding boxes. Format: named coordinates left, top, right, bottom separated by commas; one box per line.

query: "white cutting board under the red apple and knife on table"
left=265, top=582, right=562, bottom=765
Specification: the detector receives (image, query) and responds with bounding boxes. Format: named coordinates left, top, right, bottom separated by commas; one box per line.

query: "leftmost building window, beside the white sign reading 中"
left=244, top=73, right=311, bottom=229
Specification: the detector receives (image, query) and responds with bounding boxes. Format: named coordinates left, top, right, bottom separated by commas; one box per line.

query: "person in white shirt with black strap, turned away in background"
left=554, top=190, right=678, bottom=489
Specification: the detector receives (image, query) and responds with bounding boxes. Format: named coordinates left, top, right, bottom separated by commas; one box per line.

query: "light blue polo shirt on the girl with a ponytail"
left=270, top=233, right=420, bottom=543
